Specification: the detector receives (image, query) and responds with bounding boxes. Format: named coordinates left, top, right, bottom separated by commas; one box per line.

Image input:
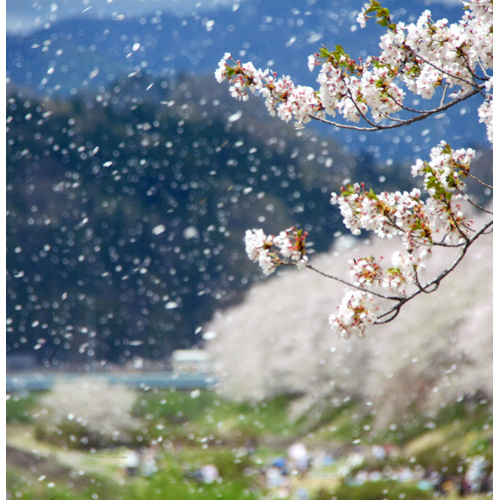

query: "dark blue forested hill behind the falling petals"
left=7, top=73, right=386, bottom=363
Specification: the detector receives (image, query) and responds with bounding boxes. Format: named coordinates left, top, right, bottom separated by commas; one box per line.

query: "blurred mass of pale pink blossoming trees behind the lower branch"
left=205, top=207, right=493, bottom=427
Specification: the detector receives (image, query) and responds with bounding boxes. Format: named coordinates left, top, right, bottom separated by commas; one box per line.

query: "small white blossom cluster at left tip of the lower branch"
left=245, top=227, right=308, bottom=276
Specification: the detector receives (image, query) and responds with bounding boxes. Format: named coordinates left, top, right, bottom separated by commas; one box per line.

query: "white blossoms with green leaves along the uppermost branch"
left=215, top=0, right=493, bottom=141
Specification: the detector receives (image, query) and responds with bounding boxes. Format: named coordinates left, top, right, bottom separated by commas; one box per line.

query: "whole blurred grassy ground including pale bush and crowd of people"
left=7, top=379, right=492, bottom=500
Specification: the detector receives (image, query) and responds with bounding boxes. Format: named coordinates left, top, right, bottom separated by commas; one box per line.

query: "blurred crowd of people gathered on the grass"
left=119, top=442, right=493, bottom=500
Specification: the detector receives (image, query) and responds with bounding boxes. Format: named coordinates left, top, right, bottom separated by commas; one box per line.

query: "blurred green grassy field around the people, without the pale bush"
left=6, top=390, right=492, bottom=500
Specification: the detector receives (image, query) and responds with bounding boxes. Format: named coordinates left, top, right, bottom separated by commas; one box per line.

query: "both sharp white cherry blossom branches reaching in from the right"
left=215, top=0, right=493, bottom=337
